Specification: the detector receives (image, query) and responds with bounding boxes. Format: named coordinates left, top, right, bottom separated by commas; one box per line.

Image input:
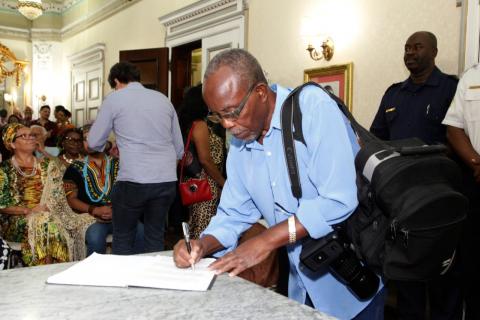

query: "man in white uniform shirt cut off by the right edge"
left=442, top=65, right=480, bottom=320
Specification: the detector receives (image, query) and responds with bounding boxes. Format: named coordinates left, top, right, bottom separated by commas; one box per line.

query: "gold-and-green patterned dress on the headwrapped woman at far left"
left=0, top=159, right=69, bottom=266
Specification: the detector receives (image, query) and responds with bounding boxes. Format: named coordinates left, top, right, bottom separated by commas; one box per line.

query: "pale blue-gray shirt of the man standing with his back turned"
left=88, top=82, right=183, bottom=183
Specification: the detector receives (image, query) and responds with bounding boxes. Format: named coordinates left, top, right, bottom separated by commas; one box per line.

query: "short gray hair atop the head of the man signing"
left=203, top=49, right=268, bottom=87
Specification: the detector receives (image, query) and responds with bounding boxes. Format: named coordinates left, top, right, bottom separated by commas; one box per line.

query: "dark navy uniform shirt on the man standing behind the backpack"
left=370, top=67, right=458, bottom=144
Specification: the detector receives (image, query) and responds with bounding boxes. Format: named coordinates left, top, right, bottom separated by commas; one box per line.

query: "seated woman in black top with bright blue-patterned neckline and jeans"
left=63, top=125, right=143, bottom=255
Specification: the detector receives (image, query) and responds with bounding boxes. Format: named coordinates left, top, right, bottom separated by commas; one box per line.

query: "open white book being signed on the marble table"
left=47, top=253, right=215, bottom=291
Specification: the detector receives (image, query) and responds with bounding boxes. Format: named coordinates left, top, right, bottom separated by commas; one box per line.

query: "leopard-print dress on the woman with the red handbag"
left=188, top=127, right=225, bottom=239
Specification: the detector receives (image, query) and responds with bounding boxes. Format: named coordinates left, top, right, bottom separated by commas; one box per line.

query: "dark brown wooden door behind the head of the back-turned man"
left=120, top=48, right=168, bottom=96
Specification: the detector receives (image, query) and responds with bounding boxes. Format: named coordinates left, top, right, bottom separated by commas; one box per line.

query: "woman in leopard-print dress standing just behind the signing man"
left=179, top=85, right=225, bottom=239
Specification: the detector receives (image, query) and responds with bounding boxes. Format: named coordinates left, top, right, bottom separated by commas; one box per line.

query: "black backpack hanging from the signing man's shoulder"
left=281, top=82, right=467, bottom=281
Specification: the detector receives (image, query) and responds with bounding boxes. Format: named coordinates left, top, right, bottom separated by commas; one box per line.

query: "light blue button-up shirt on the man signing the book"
left=204, top=85, right=378, bottom=319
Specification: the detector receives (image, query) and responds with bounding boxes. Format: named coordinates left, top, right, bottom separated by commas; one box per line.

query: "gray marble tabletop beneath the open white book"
left=0, top=254, right=334, bottom=320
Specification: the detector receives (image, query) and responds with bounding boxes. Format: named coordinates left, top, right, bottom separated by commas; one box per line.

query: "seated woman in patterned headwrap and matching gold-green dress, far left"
left=0, top=123, right=69, bottom=266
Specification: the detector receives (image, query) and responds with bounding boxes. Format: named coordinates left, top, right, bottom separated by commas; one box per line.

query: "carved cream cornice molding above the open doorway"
left=158, top=0, right=247, bottom=41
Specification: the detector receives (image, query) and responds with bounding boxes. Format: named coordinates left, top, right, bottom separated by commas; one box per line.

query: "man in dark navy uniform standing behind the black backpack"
left=370, top=31, right=462, bottom=320
